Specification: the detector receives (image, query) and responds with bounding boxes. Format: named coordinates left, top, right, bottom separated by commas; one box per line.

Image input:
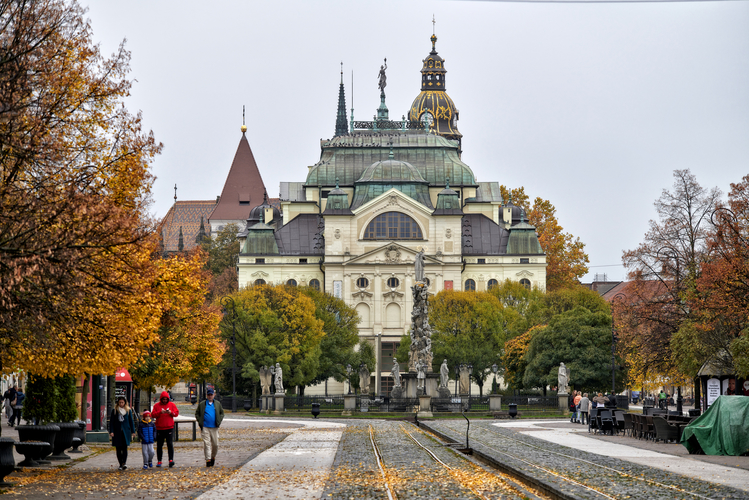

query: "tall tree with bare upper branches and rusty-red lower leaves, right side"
left=614, top=170, right=721, bottom=378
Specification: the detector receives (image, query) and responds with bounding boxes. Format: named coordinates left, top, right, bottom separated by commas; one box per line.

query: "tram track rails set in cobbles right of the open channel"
left=421, top=423, right=736, bottom=500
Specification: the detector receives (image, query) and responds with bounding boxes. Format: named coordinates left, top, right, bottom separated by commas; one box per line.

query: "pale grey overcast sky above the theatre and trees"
left=82, top=0, right=749, bottom=281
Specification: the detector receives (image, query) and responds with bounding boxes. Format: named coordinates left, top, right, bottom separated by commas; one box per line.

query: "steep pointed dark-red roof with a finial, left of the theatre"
left=210, top=134, right=265, bottom=220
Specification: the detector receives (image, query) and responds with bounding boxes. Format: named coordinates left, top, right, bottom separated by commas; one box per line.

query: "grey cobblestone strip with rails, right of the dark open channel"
left=428, top=420, right=749, bottom=500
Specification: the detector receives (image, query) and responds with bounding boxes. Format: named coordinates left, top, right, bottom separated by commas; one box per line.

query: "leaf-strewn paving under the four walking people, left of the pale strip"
left=2, top=417, right=299, bottom=500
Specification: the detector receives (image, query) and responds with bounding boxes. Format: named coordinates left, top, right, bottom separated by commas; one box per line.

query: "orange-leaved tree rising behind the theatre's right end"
left=500, top=186, right=590, bottom=290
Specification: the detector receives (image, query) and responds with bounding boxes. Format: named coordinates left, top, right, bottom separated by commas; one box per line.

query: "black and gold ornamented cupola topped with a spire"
left=408, top=35, right=463, bottom=148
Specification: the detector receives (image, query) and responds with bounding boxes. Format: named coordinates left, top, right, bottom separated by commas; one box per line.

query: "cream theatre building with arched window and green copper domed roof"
left=238, top=36, right=546, bottom=389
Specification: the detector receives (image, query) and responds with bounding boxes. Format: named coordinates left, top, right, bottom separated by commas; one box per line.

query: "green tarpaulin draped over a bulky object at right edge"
left=681, top=396, right=749, bottom=456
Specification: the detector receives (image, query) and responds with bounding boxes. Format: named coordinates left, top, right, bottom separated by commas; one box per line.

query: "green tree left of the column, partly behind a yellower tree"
left=299, top=287, right=360, bottom=384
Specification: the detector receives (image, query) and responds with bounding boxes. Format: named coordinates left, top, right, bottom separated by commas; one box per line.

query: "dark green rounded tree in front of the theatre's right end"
left=523, top=307, right=624, bottom=391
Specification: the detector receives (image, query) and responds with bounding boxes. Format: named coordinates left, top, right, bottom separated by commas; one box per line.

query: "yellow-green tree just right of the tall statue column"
left=426, top=290, right=505, bottom=393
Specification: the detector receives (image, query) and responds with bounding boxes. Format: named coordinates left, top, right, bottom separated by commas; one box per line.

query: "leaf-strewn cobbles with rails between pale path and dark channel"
left=322, top=420, right=543, bottom=500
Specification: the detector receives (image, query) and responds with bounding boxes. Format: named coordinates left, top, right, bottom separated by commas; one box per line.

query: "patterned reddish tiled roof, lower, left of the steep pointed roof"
left=159, top=200, right=216, bottom=252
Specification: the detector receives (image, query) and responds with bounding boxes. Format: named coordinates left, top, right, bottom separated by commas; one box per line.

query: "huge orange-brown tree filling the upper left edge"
left=0, top=0, right=161, bottom=376
